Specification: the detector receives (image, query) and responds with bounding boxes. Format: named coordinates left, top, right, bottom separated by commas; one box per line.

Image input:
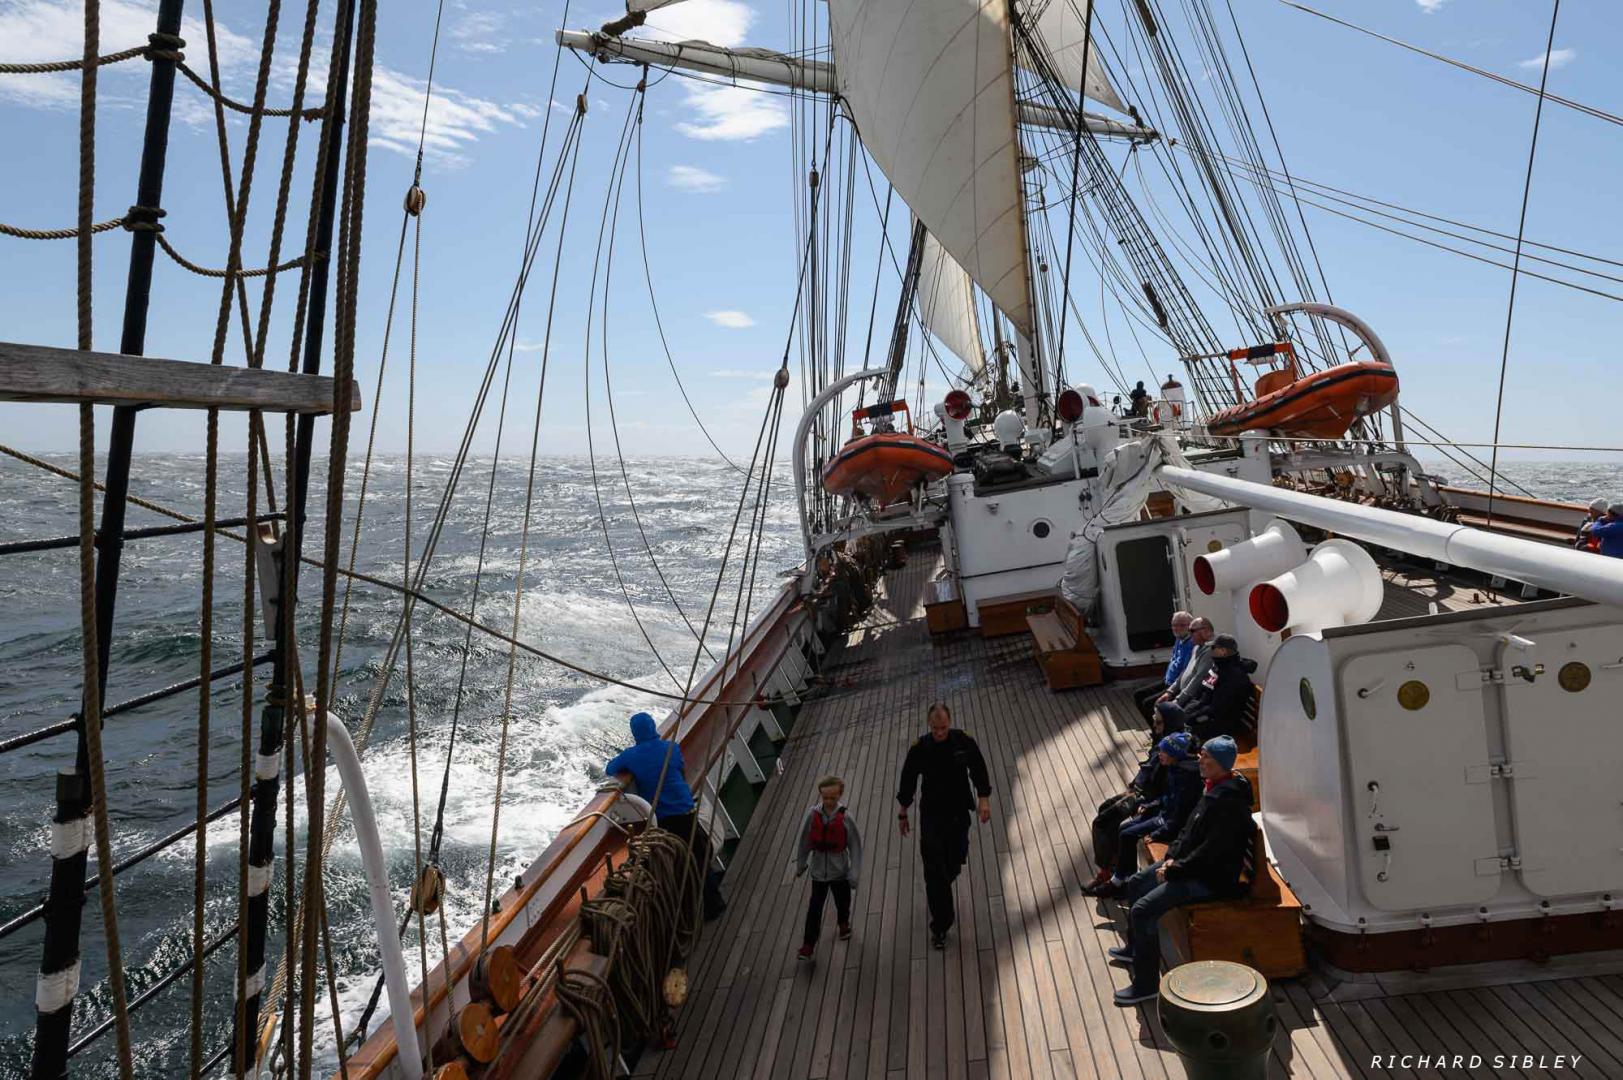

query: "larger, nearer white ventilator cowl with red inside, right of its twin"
left=1248, top=539, right=1386, bottom=633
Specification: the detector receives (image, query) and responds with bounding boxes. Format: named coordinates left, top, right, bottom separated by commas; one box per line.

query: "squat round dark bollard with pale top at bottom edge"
left=1159, top=960, right=1279, bottom=1080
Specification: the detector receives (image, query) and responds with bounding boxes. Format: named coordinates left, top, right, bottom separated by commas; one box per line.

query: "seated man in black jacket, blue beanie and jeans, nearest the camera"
left=1110, top=736, right=1255, bottom=1009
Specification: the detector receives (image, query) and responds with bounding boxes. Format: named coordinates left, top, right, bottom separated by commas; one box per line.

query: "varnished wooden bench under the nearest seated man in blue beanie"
left=1139, top=828, right=1308, bottom=979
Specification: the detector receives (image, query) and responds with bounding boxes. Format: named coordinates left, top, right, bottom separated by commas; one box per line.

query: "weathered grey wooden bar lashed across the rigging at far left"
left=0, top=341, right=360, bottom=416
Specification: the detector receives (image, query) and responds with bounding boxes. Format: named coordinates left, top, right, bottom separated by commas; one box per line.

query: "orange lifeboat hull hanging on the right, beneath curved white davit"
left=1206, top=361, right=1397, bottom=438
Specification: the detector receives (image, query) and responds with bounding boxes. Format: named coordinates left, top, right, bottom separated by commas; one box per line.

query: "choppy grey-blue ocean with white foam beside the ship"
left=0, top=455, right=1623, bottom=1078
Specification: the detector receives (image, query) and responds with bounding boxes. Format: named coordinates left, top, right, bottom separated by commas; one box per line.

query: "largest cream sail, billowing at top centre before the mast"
left=828, top=0, right=1032, bottom=333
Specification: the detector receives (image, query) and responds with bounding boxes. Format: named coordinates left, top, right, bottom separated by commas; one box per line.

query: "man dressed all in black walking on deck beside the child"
left=896, top=702, right=992, bottom=948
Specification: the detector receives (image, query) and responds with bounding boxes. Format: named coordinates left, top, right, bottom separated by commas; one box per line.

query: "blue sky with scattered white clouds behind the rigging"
left=0, top=0, right=1623, bottom=460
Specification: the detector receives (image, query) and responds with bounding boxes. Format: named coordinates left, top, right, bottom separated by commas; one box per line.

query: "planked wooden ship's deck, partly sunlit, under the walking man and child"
left=636, top=551, right=1623, bottom=1080
